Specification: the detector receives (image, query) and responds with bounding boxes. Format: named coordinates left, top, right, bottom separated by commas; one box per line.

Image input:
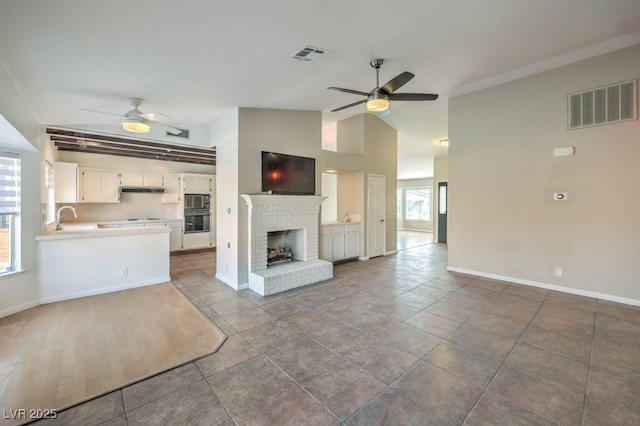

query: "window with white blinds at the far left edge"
left=0, top=153, right=20, bottom=274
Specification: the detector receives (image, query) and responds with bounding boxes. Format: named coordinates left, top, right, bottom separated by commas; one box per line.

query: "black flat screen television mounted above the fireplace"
left=262, top=151, right=316, bottom=195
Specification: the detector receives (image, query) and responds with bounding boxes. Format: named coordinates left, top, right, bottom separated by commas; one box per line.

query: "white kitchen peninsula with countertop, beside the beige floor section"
left=36, top=223, right=170, bottom=303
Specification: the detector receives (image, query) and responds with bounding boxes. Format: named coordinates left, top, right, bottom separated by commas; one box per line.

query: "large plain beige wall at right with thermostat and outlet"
left=448, top=46, right=640, bottom=304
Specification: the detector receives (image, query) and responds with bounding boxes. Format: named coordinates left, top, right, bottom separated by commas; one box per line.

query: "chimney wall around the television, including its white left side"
left=212, top=108, right=323, bottom=289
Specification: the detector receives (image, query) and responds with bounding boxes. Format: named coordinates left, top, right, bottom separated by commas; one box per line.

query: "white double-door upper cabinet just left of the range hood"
left=78, top=167, right=120, bottom=203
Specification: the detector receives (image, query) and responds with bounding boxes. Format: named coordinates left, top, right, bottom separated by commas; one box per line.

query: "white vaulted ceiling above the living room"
left=0, top=0, right=640, bottom=178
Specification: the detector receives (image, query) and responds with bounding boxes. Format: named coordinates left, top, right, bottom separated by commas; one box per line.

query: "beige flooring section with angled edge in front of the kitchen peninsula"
left=0, top=283, right=226, bottom=425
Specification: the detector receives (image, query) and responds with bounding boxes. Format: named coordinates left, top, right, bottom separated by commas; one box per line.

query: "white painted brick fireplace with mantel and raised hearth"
left=242, top=194, right=333, bottom=296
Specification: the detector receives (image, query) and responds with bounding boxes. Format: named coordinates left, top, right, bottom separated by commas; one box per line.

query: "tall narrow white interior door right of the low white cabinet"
left=367, top=174, right=386, bottom=258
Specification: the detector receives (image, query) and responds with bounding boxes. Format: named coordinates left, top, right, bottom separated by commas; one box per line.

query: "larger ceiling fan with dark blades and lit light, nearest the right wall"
left=328, top=59, right=438, bottom=112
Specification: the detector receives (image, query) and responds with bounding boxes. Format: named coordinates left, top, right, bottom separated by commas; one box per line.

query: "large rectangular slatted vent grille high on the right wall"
left=567, top=80, right=638, bottom=130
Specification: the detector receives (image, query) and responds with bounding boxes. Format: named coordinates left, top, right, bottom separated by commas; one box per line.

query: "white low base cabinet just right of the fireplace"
left=320, top=222, right=360, bottom=262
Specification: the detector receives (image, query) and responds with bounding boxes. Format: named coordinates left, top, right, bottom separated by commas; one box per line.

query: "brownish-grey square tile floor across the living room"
left=35, top=243, right=640, bottom=425
